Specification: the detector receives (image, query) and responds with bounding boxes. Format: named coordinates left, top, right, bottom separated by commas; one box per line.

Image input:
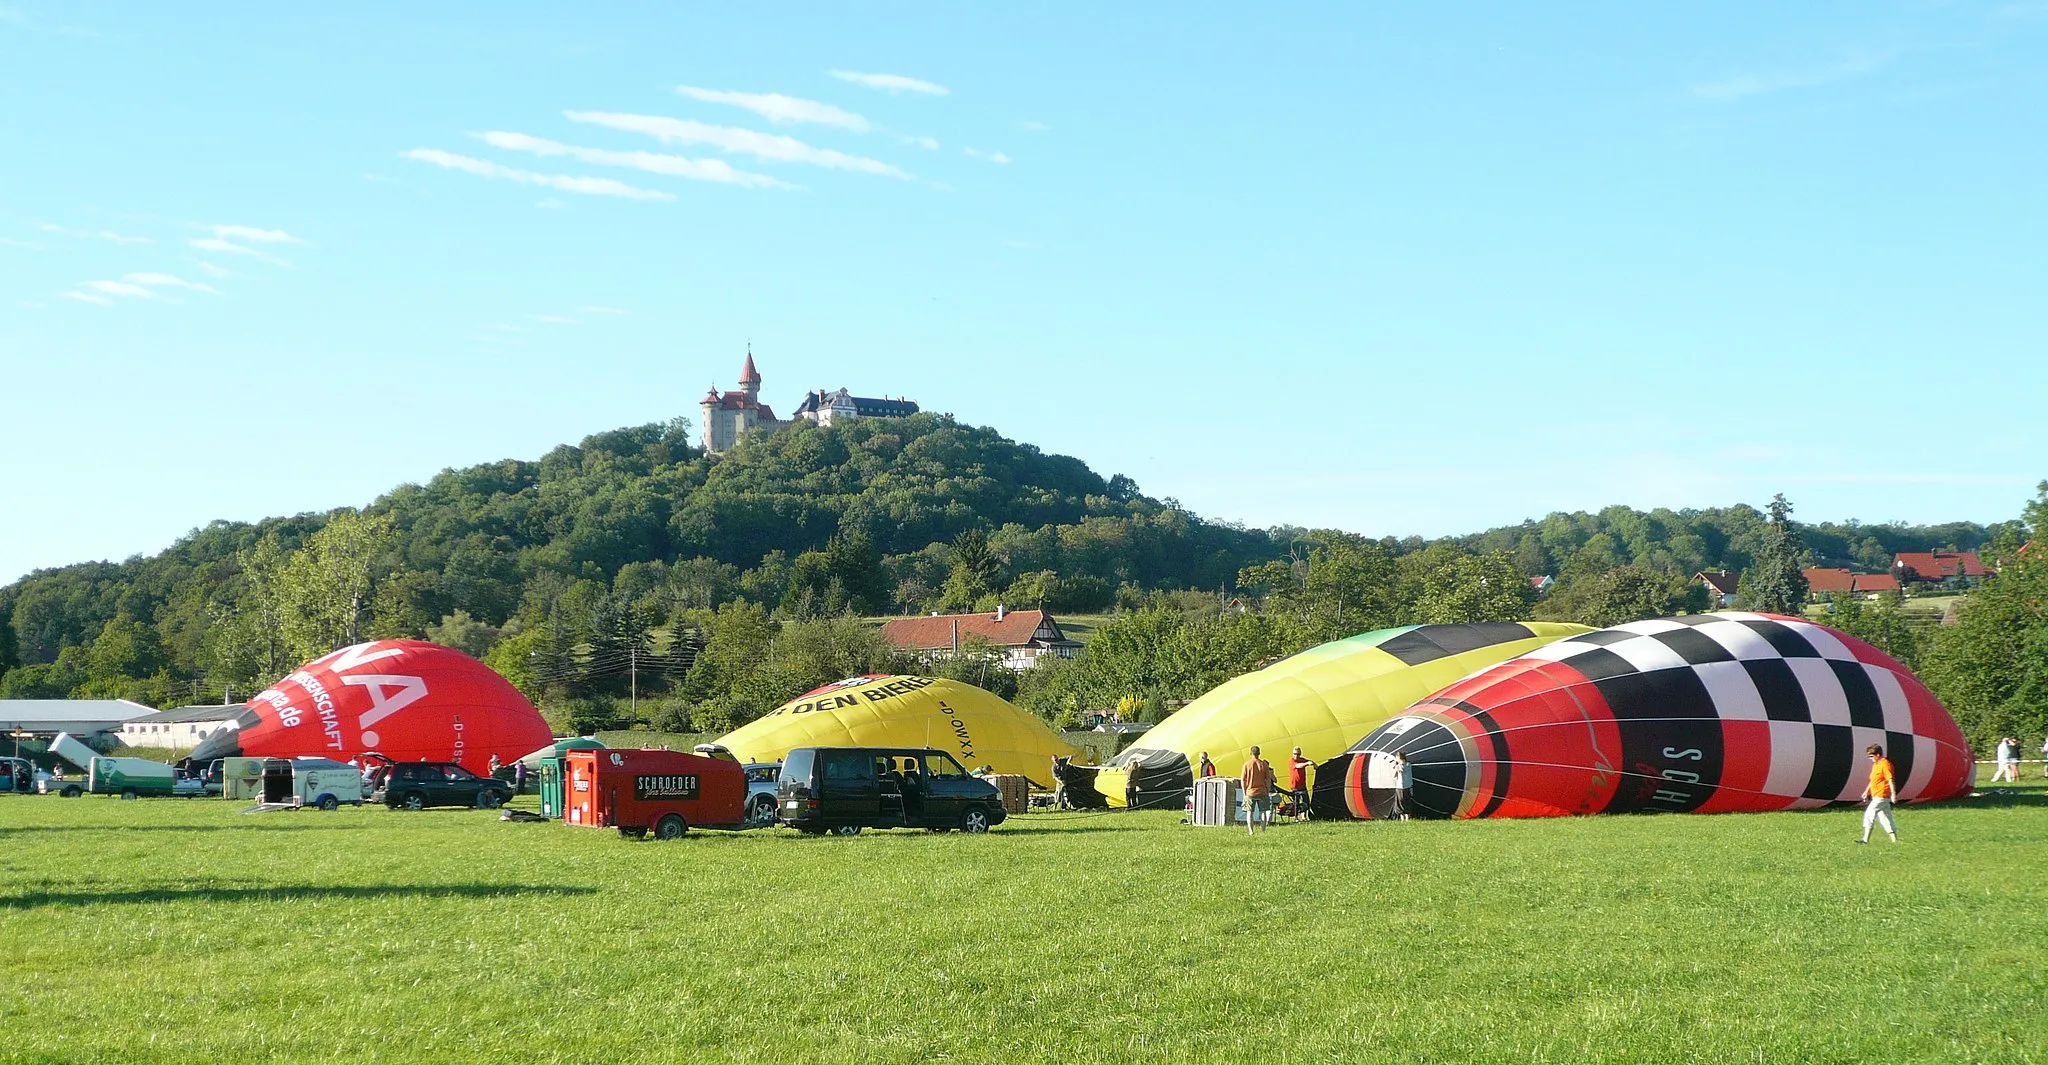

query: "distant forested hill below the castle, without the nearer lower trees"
left=0, top=414, right=1987, bottom=705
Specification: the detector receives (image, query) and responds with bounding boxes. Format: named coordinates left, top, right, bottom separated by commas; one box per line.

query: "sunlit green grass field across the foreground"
left=0, top=766, right=2048, bottom=1065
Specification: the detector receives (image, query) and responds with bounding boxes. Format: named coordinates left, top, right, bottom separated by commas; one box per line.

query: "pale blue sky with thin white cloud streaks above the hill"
left=0, top=0, right=2048, bottom=580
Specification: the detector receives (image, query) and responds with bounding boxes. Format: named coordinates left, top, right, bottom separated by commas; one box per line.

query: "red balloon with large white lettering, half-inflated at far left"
left=193, top=639, right=553, bottom=770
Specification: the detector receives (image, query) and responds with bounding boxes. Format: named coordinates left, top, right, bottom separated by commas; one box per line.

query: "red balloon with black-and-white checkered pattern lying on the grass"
left=1346, top=612, right=1976, bottom=817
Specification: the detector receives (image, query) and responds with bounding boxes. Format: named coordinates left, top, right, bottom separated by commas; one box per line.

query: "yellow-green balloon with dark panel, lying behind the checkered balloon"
left=1096, top=621, right=1591, bottom=817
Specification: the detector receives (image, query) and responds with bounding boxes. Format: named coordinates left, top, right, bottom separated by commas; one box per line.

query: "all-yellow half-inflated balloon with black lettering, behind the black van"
left=719, top=676, right=1081, bottom=784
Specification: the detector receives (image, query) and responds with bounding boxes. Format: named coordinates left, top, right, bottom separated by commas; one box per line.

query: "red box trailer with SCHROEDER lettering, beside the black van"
left=561, top=748, right=748, bottom=840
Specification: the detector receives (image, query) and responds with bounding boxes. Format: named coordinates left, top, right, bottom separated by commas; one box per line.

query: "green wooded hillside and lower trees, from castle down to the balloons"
left=0, top=414, right=2017, bottom=741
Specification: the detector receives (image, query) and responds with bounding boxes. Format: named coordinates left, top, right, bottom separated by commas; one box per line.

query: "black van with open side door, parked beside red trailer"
left=776, top=748, right=1004, bottom=836
